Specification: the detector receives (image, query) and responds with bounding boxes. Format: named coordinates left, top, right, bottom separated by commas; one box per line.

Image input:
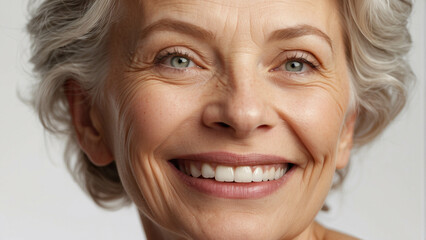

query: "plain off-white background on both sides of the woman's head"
left=0, top=0, right=426, bottom=240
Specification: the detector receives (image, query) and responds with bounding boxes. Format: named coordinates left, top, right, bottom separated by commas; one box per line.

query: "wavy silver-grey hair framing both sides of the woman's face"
left=27, top=0, right=414, bottom=208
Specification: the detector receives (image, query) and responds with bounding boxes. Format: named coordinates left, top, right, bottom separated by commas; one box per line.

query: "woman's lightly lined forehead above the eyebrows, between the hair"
left=121, top=0, right=340, bottom=44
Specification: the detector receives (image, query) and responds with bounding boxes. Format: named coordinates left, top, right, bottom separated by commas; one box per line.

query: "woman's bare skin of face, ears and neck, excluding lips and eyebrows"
left=66, top=0, right=355, bottom=240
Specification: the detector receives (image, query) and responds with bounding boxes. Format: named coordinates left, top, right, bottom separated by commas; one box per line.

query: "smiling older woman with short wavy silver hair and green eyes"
left=28, top=0, right=412, bottom=239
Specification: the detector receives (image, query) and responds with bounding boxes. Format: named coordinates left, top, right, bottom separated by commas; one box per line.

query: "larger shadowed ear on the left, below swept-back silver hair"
left=64, top=80, right=113, bottom=166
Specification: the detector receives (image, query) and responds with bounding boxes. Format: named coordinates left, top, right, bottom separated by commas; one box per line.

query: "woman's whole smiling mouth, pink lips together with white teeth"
left=169, top=152, right=294, bottom=198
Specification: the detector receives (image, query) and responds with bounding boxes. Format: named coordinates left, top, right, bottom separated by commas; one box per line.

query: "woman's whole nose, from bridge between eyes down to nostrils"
left=204, top=54, right=272, bottom=138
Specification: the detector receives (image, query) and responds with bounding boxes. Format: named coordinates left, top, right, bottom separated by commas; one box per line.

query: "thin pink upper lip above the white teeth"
left=174, top=152, right=290, bottom=166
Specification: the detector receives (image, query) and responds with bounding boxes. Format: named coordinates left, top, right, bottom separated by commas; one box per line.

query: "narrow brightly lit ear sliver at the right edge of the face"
left=336, top=111, right=357, bottom=169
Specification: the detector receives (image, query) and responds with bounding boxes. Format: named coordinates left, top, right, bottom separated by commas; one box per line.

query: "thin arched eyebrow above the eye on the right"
left=268, top=24, right=333, bottom=50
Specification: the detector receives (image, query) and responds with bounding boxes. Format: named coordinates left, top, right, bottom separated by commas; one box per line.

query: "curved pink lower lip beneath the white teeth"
left=169, top=163, right=296, bottom=199
